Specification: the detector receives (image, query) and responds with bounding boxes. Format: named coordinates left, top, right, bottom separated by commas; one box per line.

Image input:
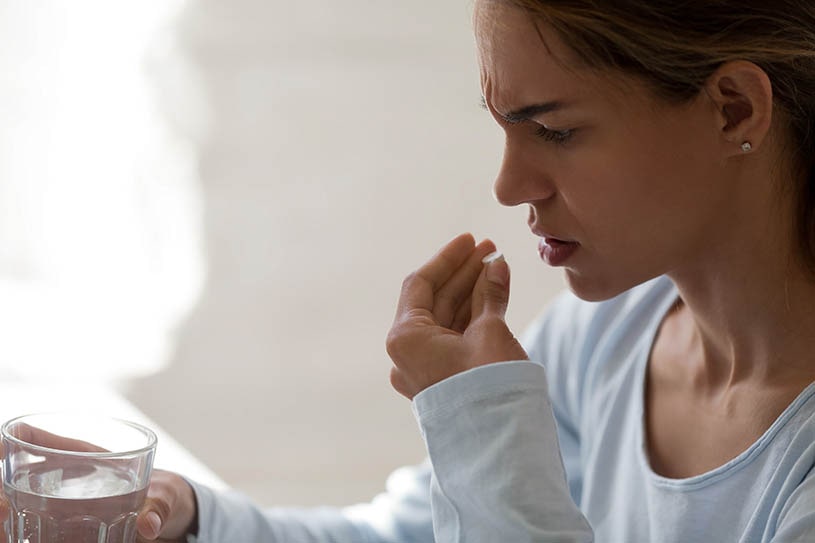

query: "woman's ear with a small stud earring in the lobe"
left=705, top=60, right=773, bottom=155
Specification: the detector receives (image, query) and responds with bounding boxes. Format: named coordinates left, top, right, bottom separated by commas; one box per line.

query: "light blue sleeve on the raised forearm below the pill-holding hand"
left=413, top=361, right=593, bottom=543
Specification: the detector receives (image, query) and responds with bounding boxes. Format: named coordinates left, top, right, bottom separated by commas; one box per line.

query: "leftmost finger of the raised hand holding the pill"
left=397, top=233, right=475, bottom=319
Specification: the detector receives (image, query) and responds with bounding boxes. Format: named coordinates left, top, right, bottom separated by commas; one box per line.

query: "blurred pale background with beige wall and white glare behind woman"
left=0, top=0, right=562, bottom=505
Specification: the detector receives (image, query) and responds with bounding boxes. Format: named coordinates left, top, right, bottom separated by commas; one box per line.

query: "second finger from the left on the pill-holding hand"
left=433, top=240, right=495, bottom=329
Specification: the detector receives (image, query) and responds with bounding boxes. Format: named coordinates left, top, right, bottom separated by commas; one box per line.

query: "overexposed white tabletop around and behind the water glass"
left=0, top=382, right=227, bottom=489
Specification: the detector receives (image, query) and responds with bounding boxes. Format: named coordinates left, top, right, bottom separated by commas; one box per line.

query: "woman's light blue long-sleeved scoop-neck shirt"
left=188, top=278, right=815, bottom=543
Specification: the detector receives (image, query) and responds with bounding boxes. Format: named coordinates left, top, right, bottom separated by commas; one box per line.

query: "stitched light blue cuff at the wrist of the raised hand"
left=413, top=360, right=547, bottom=420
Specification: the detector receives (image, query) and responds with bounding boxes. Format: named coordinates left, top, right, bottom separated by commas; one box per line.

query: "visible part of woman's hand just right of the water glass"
left=136, top=470, right=198, bottom=543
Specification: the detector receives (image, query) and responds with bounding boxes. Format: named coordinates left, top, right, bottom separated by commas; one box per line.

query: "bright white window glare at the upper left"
left=0, top=0, right=203, bottom=380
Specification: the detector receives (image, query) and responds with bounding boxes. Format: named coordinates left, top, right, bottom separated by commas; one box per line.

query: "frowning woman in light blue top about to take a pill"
left=135, top=0, right=815, bottom=543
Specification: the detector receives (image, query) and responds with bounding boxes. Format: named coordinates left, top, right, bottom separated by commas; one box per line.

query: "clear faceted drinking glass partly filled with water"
left=0, top=413, right=156, bottom=543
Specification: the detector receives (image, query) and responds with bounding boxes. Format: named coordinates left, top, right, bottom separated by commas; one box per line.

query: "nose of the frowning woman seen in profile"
left=493, top=142, right=555, bottom=207
